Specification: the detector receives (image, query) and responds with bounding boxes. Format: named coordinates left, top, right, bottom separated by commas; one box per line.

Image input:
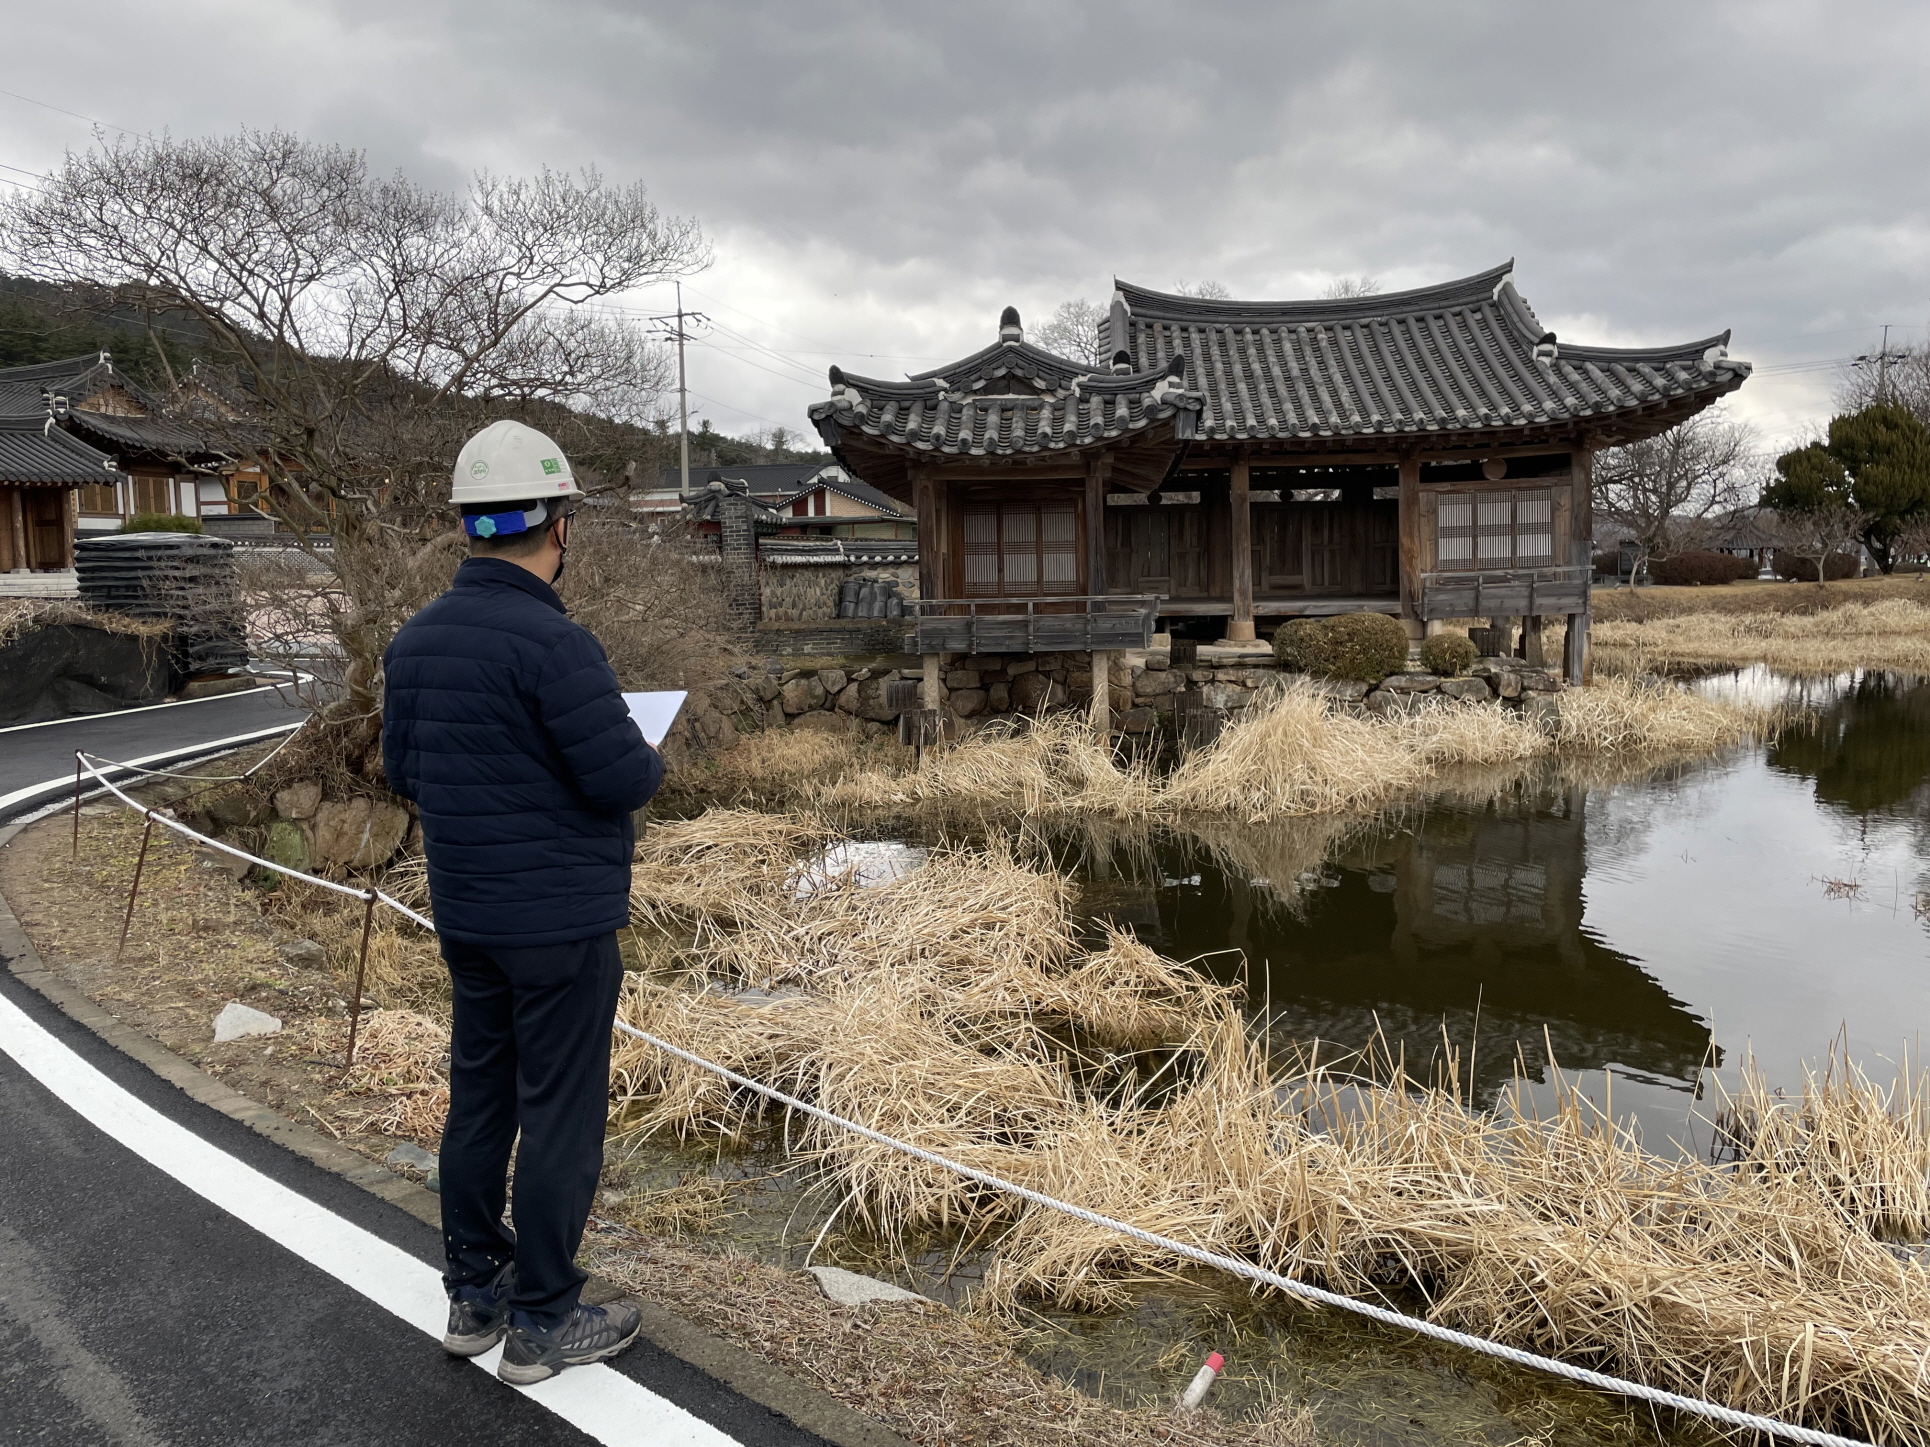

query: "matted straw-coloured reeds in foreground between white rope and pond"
left=614, top=814, right=1930, bottom=1443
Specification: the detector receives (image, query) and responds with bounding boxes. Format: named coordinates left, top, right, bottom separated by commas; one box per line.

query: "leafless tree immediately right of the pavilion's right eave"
left=1594, top=411, right=1754, bottom=577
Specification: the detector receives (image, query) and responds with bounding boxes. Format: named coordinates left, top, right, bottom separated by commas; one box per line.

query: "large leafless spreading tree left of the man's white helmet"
left=0, top=131, right=706, bottom=764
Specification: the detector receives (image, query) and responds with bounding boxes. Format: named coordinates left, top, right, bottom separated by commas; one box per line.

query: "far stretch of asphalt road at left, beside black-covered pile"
left=0, top=687, right=305, bottom=822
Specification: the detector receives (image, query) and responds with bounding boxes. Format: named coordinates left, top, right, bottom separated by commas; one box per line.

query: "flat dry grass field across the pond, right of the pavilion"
left=1594, top=598, right=1930, bottom=675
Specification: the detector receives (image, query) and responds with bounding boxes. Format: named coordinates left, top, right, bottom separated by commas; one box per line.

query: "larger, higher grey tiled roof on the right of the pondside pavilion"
left=1103, top=262, right=1749, bottom=442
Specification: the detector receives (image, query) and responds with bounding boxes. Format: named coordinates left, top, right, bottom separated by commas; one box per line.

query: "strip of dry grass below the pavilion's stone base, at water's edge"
left=787, top=679, right=1778, bottom=822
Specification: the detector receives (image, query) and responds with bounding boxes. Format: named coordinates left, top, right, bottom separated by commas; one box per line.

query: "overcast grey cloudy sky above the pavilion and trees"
left=0, top=0, right=1930, bottom=453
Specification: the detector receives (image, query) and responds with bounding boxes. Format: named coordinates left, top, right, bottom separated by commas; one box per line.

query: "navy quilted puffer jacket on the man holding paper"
left=382, top=558, right=664, bottom=947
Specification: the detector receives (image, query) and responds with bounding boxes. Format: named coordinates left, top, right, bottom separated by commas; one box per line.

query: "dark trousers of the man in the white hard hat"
left=440, top=934, right=623, bottom=1327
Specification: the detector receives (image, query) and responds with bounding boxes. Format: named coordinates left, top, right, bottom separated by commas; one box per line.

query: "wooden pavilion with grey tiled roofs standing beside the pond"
left=811, top=262, right=1749, bottom=681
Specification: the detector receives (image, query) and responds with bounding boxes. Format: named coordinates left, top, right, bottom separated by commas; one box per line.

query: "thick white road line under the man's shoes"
left=0, top=996, right=737, bottom=1447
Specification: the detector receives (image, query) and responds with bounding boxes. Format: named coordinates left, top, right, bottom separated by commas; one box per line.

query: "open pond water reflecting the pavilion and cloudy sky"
left=1081, top=669, right=1930, bottom=1146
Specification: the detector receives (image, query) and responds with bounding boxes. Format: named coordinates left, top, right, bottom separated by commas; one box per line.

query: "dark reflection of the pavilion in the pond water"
left=1089, top=779, right=1712, bottom=1102
